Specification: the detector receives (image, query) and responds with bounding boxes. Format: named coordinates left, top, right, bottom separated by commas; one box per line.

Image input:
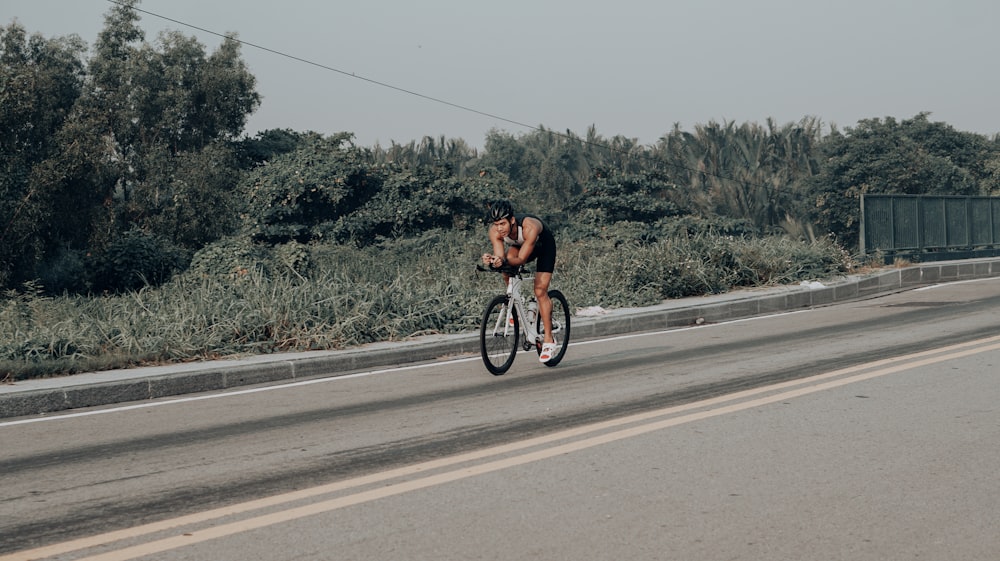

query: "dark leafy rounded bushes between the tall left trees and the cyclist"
left=243, top=134, right=509, bottom=246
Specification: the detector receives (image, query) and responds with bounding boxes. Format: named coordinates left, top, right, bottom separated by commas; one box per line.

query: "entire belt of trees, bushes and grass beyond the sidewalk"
left=0, top=0, right=1000, bottom=376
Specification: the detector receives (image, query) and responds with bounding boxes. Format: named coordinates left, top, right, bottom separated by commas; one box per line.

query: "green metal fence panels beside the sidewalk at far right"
left=860, top=195, right=1000, bottom=253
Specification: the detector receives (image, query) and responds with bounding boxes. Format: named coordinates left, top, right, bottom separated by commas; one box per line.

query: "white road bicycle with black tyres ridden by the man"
left=476, top=265, right=570, bottom=376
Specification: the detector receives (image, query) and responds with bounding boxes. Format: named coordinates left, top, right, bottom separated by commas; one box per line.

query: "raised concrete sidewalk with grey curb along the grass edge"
left=0, top=258, right=1000, bottom=418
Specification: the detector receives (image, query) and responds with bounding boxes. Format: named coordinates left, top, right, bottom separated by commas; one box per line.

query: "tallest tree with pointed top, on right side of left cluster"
left=51, top=0, right=259, bottom=272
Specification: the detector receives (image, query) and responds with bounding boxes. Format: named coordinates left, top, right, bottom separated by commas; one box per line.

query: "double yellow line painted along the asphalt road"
left=7, top=336, right=1000, bottom=561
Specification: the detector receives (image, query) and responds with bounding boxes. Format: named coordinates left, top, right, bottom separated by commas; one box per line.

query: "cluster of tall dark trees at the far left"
left=0, top=0, right=259, bottom=294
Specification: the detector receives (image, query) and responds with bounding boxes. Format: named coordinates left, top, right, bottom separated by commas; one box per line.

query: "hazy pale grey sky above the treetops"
left=0, top=0, right=1000, bottom=147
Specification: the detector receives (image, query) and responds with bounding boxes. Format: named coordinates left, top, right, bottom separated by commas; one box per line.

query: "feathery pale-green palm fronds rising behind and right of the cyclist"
left=481, top=118, right=822, bottom=236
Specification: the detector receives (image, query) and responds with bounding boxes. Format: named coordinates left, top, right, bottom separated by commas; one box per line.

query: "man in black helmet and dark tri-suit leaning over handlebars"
left=483, top=201, right=557, bottom=362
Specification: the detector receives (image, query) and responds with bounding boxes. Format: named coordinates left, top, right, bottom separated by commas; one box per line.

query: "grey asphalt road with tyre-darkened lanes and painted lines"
left=0, top=279, right=1000, bottom=561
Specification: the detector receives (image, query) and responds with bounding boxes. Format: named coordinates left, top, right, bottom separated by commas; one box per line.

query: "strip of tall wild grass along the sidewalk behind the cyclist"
left=0, top=231, right=850, bottom=379
